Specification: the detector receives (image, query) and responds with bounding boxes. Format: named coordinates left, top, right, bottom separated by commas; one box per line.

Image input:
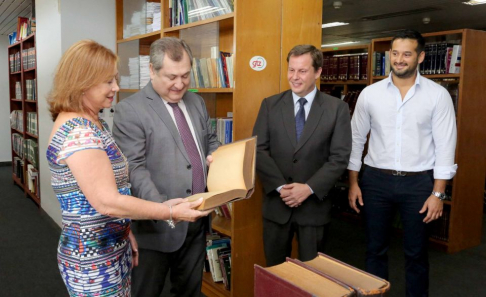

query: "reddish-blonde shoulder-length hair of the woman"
left=47, top=40, right=118, bottom=121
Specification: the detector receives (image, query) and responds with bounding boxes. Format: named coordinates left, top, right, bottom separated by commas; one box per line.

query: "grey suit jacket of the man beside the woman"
left=113, top=83, right=219, bottom=252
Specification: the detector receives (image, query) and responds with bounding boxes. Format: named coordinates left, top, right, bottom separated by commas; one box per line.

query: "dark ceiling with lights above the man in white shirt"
left=324, top=0, right=486, bottom=44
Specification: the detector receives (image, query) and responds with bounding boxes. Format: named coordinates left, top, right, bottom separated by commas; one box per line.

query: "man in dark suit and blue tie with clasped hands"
left=253, top=45, right=351, bottom=266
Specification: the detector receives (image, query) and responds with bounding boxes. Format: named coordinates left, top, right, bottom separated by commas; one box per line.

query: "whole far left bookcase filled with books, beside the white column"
left=8, top=33, right=40, bottom=205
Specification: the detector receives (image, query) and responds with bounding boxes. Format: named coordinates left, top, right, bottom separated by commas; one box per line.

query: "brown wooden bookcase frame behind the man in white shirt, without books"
left=369, top=29, right=486, bottom=253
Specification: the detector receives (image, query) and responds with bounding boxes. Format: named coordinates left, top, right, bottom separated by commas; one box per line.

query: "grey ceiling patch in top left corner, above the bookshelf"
left=0, top=0, right=32, bottom=35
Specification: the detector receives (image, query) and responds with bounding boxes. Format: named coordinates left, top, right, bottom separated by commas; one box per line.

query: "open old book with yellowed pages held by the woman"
left=188, top=136, right=256, bottom=210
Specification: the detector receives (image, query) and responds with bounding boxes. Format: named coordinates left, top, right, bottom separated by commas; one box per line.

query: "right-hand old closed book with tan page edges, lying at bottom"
left=303, top=253, right=390, bottom=296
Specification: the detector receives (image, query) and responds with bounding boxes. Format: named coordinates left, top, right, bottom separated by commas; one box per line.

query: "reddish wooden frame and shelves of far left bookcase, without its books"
left=8, top=34, right=40, bottom=205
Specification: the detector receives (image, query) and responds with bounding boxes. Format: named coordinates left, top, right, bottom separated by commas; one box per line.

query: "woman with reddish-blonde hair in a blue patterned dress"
left=47, top=40, right=213, bottom=296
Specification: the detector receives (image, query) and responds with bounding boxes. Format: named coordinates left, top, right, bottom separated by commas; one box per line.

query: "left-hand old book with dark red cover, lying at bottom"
left=254, top=259, right=355, bottom=297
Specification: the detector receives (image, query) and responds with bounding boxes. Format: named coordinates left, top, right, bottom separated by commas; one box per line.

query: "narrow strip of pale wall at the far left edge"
left=0, top=35, right=12, bottom=162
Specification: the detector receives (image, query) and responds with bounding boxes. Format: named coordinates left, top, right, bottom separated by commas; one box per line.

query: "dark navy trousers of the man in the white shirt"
left=360, top=166, right=434, bottom=297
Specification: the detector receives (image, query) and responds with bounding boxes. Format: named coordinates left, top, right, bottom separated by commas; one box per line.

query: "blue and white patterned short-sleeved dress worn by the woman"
left=47, top=118, right=132, bottom=297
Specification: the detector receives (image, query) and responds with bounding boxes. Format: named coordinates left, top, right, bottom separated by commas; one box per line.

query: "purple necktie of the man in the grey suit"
left=169, top=103, right=206, bottom=194
